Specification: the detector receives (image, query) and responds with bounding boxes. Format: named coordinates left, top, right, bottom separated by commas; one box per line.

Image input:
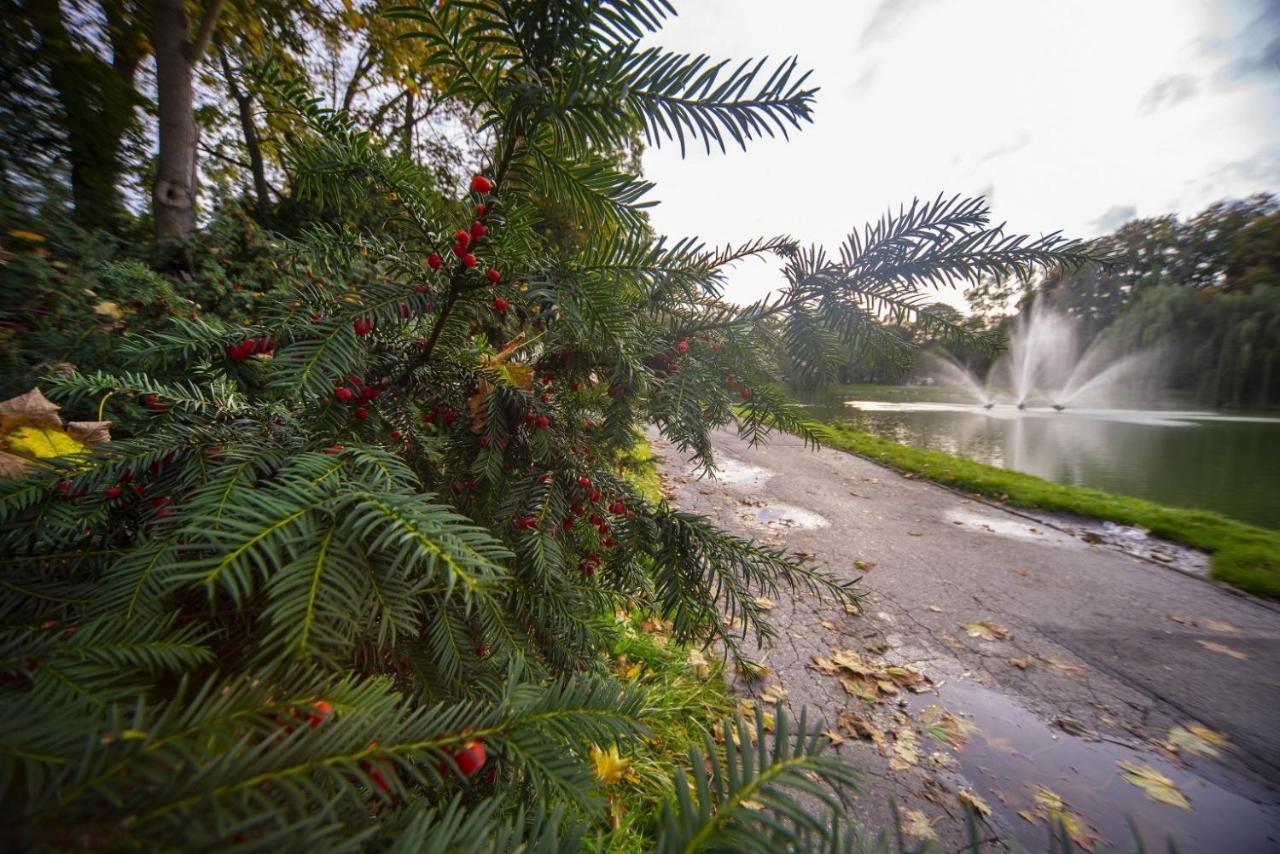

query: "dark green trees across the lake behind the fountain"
left=819, top=193, right=1280, bottom=408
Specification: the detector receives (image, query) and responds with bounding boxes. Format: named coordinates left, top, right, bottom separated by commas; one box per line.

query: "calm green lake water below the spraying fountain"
left=810, top=385, right=1280, bottom=528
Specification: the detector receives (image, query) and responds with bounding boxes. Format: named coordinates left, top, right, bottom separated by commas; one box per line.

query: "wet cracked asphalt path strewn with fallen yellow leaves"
left=649, top=431, right=1280, bottom=851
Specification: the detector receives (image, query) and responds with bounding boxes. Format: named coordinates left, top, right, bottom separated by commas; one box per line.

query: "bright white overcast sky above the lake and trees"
left=644, top=0, right=1280, bottom=302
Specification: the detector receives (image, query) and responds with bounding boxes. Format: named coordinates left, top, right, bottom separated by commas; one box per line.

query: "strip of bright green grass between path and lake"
left=813, top=423, right=1280, bottom=599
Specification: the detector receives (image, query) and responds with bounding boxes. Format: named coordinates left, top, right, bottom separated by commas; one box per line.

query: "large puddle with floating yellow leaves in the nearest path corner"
left=909, top=681, right=1280, bottom=851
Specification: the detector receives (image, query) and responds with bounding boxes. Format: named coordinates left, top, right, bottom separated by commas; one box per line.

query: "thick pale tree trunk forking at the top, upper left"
left=151, top=0, right=223, bottom=242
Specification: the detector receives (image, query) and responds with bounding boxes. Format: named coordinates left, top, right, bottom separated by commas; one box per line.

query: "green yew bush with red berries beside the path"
left=0, top=0, right=1088, bottom=850
